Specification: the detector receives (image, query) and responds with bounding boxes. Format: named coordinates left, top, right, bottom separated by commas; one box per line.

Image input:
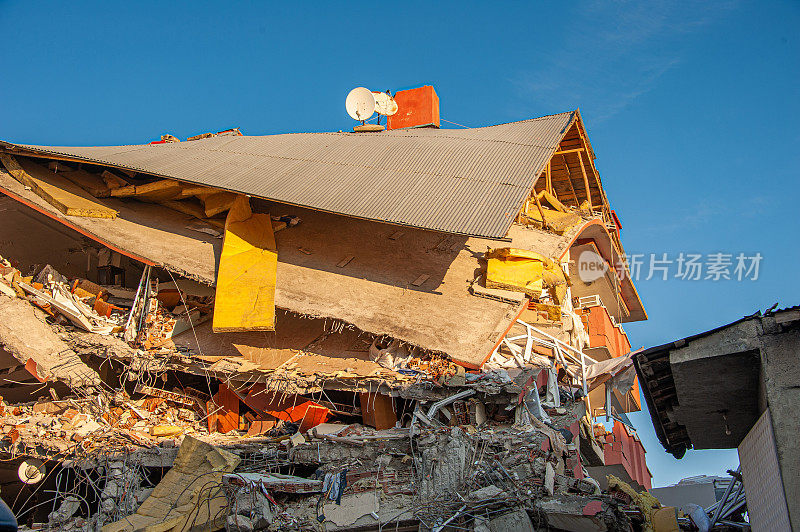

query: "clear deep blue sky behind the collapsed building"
left=0, top=1, right=800, bottom=485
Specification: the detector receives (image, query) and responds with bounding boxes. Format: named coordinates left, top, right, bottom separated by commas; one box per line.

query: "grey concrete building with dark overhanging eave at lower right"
left=634, top=307, right=800, bottom=530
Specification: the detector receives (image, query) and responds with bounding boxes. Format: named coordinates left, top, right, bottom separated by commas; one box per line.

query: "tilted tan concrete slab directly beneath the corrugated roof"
left=0, top=170, right=608, bottom=367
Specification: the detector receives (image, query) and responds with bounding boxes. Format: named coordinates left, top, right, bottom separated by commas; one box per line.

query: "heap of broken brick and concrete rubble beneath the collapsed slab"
left=0, top=251, right=648, bottom=530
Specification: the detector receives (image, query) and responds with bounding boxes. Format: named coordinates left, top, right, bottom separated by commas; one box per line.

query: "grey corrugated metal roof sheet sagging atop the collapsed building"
left=3, top=112, right=576, bottom=238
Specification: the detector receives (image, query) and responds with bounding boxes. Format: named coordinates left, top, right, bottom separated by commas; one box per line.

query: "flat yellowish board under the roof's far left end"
left=0, top=153, right=117, bottom=218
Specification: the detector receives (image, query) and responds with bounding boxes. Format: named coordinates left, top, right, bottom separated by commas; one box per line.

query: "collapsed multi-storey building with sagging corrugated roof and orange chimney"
left=0, top=87, right=664, bottom=531
